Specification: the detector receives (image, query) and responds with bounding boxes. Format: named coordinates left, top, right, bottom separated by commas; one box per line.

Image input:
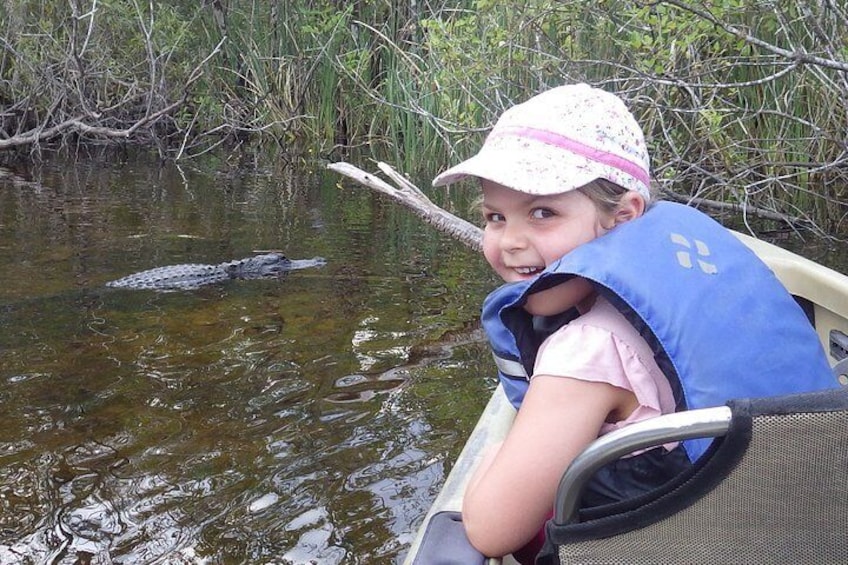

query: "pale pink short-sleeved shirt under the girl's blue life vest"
left=533, top=296, right=675, bottom=436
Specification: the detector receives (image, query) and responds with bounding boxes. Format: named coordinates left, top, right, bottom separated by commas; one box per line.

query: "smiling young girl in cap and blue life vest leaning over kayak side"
left=433, top=84, right=835, bottom=560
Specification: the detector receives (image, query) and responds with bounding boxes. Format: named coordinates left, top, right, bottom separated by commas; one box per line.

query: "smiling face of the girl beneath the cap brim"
left=481, top=179, right=612, bottom=282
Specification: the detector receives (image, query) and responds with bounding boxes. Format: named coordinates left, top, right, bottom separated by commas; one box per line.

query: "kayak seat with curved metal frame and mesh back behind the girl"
left=537, top=388, right=848, bottom=565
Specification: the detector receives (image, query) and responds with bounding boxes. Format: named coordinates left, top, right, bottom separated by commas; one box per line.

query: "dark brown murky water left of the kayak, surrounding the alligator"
left=0, top=151, right=495, bottom=564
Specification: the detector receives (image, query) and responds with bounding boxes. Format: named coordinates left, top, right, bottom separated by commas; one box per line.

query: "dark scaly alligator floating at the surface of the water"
left=106, top=253, right=326, bottom=290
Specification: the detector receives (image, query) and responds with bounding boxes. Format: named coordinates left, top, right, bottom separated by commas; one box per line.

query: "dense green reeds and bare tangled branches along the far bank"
left=0, top=0, right=848, bottom=233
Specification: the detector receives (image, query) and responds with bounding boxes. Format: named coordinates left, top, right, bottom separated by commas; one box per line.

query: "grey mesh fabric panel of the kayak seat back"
left=549, top=391, right=848, bottom=565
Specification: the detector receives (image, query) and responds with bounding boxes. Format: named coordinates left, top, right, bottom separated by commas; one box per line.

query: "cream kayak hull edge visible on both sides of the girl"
left=403, top=232, right=848, bottom=565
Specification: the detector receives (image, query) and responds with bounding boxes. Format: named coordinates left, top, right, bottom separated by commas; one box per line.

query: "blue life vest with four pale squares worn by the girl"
left=483, top=202, right=839, bottom=461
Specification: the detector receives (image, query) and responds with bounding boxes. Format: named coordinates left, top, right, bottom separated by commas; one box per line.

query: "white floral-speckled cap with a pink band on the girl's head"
left=433, top=84, right=651, bottom=199
